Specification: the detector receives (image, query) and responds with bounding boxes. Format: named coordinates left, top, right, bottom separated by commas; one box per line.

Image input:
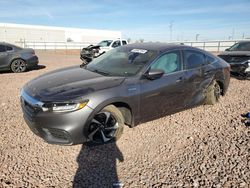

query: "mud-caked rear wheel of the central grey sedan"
left=205, top=80, right=221, bottom=105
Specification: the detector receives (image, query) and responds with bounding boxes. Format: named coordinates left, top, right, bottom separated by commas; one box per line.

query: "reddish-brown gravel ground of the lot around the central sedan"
left=0, top=52, right=250, bottom=187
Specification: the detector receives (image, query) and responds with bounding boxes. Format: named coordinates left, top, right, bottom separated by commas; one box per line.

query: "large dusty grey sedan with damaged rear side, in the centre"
left=21, top=43, right=230, bottom=145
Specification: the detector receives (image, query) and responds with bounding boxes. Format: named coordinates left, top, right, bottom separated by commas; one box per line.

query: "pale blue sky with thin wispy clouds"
left=0, top=0, right=250, bottom=41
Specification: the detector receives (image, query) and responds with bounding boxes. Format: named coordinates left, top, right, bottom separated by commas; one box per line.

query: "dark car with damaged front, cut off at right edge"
left=218, top=41, right=250, bottom=78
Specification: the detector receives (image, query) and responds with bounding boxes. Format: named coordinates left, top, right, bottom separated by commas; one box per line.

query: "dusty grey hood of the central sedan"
left=24, top=66, right=125, bottom=102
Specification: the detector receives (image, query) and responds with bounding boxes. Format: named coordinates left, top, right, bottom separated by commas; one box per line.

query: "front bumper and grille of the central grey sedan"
left=21, top=91, right=93, bottom=145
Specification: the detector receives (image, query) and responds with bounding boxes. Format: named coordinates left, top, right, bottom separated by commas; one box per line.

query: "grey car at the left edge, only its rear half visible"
left=0, top=42, right=38, bottom=73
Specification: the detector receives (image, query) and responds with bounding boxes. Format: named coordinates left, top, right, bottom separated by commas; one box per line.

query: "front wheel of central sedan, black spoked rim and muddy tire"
left=85, top=105, right=125, bottom=145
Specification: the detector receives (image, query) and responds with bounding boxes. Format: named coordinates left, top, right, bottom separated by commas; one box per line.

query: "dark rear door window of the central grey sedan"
left=184, top=50, right=206, bottom=69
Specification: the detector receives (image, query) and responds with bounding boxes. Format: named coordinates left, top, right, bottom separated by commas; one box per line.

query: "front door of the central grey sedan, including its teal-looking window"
left=140, top=50, right=187, bottom=121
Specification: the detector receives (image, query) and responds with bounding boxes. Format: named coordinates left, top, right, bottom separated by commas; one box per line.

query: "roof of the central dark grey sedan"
left=124, top=42, right=192, bottom=52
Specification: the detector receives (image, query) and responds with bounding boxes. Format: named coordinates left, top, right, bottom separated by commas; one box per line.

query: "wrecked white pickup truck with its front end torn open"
left=80, top=39, right=128, bottom=64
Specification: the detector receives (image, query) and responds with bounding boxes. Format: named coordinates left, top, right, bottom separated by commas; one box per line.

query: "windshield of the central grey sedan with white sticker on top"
left=84, top=46, right=157, bottom=77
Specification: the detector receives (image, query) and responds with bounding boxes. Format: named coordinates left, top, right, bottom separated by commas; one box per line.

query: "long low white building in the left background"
left=0, top=23, right=121, bottom=45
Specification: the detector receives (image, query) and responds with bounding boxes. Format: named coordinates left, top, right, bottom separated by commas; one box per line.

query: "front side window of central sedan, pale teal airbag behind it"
left=151, top=51, right=181, bottom=74
